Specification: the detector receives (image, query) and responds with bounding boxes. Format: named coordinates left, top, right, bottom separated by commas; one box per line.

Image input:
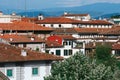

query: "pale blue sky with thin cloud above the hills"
left=0, top=0, right=120, bottom=10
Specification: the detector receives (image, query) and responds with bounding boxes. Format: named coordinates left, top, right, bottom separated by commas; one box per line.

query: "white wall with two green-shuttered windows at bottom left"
left=0, top=61, right=51, bottom=80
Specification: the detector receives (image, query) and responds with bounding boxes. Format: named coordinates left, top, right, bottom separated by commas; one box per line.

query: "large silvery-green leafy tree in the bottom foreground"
left=44, top=53, right=114, bottom=80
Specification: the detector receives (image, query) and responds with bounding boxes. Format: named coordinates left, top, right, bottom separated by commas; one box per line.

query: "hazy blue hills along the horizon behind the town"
left=1, top=3, right=120, bottom=18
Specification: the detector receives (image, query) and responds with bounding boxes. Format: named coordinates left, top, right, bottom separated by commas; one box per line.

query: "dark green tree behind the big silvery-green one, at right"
left=96, top=44, right=117, bottom=71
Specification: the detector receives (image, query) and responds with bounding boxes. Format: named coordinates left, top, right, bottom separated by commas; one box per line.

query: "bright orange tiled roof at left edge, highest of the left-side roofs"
left=0, top=21, right=53, bottom=31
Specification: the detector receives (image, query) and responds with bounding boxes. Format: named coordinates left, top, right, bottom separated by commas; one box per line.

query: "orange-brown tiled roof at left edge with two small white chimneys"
left=0, top=34, right=45, bottom=43
